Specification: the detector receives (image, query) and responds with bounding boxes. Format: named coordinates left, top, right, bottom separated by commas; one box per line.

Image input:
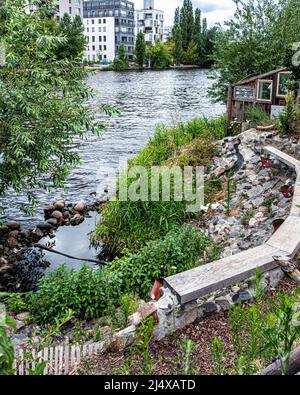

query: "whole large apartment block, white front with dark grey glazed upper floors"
left=83, top=0, right=135, bottom=62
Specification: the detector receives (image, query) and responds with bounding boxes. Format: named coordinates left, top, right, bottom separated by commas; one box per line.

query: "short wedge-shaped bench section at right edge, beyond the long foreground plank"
left=267, top=216, right=300, bottom=257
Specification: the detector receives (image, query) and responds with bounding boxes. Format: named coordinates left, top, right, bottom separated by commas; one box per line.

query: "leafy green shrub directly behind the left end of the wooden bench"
left=112, top=225, right=214, bottom=297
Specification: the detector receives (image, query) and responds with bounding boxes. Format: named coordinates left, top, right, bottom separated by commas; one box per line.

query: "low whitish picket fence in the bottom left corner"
left=14, top=342, right=103, bottom=376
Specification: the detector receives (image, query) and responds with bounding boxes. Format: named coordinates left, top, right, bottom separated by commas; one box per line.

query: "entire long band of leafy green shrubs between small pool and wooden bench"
left=15, top=225, right=214, bottom=323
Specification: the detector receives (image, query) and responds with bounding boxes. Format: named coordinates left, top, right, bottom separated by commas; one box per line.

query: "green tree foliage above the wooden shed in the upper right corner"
left=210, top=0, right=300, bottom=101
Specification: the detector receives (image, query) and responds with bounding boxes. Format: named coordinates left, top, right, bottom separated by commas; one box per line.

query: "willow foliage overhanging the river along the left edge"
left=0, top=0, right=109, bottom=201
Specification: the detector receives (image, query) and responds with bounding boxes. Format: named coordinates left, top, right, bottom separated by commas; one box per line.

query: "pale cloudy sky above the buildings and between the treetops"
left=133, top=0, right=235, bottom=27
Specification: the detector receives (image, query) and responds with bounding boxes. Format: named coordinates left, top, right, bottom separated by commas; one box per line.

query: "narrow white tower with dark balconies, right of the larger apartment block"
left=136, top=0, right=164, bottom=44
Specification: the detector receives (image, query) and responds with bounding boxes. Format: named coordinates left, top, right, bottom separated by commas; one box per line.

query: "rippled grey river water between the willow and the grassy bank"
left=0, top=69, right=225, bottom=227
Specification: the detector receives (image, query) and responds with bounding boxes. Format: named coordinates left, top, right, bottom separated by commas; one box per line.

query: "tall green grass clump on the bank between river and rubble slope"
left=94, top=117, right=226, bottom=255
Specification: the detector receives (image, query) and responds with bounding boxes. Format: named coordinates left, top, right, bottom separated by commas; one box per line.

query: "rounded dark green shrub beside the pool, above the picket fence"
left=25, top=265, right=122, bottom=323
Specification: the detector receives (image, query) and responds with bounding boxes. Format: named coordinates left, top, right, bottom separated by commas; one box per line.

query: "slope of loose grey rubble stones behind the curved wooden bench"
left=202, top=130, right=299, bottom=258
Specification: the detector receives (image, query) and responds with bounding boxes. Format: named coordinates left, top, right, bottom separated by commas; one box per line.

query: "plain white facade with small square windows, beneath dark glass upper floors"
left=83, top=17, right=116, bottom=62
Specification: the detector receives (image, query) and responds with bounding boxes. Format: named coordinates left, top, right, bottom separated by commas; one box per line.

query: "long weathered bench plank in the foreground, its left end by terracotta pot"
left=165, top=244, right=284, bottom=304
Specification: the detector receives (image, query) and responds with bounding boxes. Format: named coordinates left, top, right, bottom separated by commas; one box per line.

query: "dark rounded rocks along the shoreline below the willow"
left=0, top=200, right=102, bottom=292
